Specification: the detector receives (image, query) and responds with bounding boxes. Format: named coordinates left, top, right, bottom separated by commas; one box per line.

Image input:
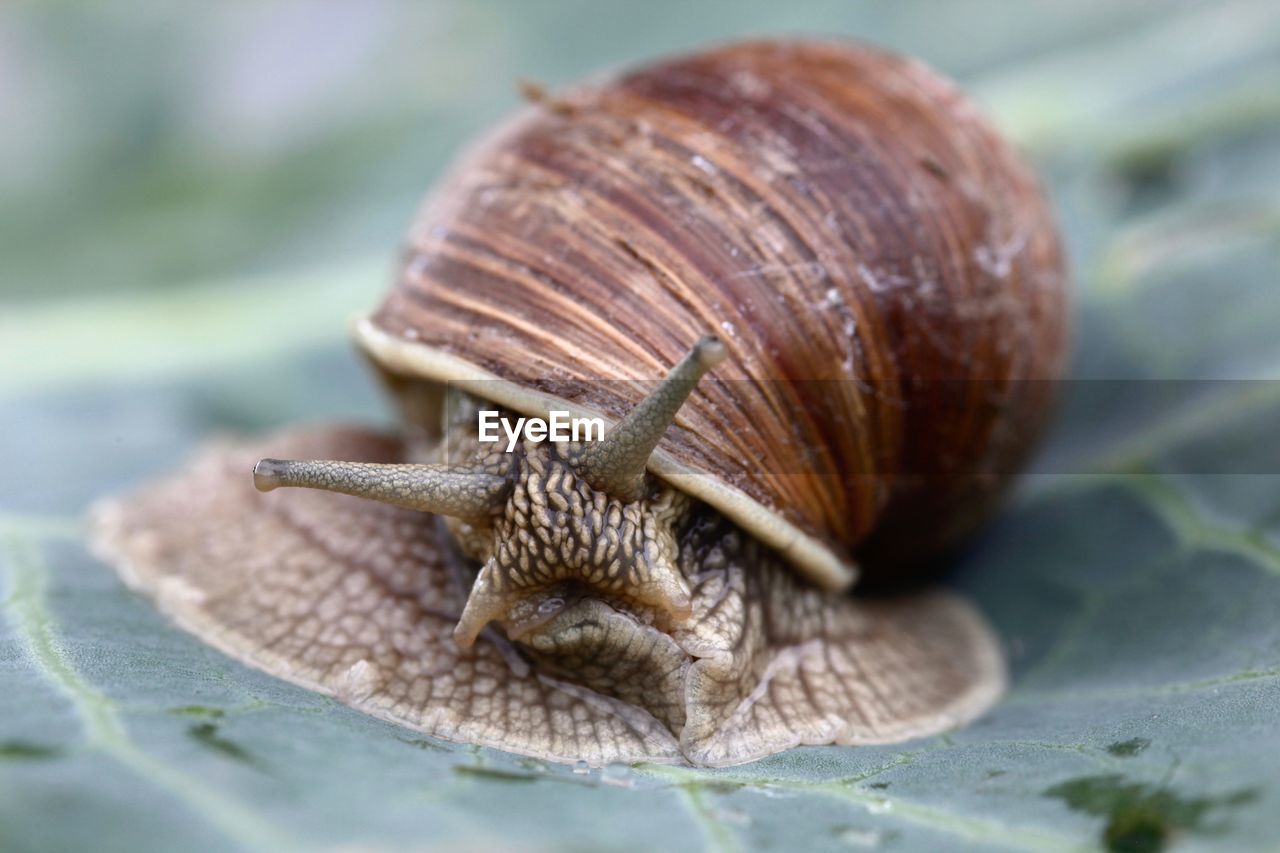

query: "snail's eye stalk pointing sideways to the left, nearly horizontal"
left=253, top=459, right=511, bottom=519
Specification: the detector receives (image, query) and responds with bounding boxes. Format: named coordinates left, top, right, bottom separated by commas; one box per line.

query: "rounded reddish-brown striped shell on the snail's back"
left=358, top=40, right=1068, bottom=588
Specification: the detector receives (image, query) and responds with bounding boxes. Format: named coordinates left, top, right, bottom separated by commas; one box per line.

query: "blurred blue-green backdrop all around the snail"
left=0, top=0, right=1280, bottom=849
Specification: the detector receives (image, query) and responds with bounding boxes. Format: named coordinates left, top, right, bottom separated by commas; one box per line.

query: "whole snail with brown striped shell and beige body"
left=93, top=40, right=1068, bottom=766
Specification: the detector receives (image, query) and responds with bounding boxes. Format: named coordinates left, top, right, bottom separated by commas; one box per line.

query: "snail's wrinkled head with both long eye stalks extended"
left=253, top=336, right=726, bottom=647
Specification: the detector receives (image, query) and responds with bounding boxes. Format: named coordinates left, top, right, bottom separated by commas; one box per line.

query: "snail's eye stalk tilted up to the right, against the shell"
left=570, top=334, right=727, bottom=501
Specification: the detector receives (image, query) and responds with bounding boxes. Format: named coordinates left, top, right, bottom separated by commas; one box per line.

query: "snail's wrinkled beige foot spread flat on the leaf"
left=93, top=429, right=1002, bottom=765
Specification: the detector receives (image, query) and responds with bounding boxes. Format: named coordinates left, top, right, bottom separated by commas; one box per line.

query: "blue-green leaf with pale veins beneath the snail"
left=0, top=0, right=1280, bottom=850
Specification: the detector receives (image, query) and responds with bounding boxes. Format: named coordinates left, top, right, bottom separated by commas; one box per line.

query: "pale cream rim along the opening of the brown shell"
left=352, top=316, right=858, bottom=592
